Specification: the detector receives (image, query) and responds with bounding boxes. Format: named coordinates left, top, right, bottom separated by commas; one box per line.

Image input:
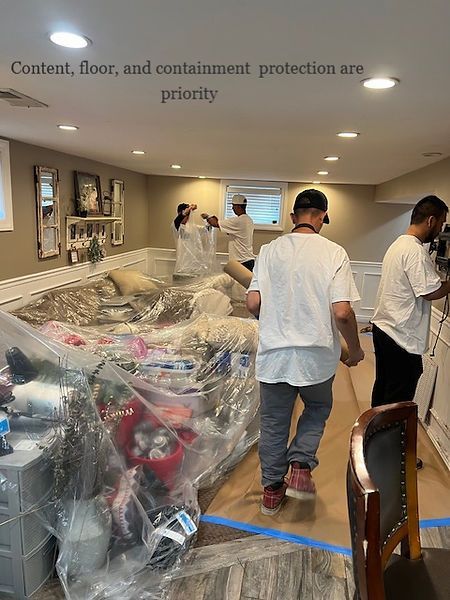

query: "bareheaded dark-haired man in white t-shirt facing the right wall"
left=372, top=196, right=450, bottom=410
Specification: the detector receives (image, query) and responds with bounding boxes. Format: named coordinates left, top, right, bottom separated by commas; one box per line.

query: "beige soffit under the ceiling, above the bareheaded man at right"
left=375, top=158, right=450, bottom=205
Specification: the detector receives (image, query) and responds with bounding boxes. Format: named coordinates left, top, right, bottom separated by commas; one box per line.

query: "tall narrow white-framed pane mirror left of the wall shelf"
left=34, top=166, right=61, bottom=258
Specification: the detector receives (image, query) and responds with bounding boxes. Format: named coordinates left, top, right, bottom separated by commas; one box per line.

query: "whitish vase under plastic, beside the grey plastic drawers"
left=58, top=497, right=111, bottom=577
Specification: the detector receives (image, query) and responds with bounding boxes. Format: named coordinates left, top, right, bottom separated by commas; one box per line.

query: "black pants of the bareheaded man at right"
left=372, top=325, right=423, bottom=406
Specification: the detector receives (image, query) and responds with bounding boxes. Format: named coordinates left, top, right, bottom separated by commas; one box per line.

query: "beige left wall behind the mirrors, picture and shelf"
left=0, top=141, right=149, bottom=280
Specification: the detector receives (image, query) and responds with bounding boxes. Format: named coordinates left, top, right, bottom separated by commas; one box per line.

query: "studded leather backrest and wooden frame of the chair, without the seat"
left=347, top=402, right=420, bottom=600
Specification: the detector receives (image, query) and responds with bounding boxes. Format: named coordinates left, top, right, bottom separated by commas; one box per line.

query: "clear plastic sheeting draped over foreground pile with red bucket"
left=0, top=313, right=259, bottom=600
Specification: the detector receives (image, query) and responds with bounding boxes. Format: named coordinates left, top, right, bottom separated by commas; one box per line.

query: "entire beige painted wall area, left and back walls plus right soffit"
left=0, top=141, right=432, bottom=280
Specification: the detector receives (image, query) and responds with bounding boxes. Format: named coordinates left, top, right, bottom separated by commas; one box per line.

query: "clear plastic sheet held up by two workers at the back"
left=173, top=220, right=219, bottom=279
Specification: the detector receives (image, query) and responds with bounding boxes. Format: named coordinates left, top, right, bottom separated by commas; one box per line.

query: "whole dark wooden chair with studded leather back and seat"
left=347, top=402, right=450, bottom=600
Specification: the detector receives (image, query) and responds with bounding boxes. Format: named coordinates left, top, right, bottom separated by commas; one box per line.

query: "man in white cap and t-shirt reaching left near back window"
left=202, top=194, right=255, bottom=271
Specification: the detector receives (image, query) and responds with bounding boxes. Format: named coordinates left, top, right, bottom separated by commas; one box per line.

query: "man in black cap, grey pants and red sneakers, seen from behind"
left=247, top=189, right=364, bottom=515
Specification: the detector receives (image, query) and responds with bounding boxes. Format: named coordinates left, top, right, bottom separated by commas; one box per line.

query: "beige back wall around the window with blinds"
left=148, top=175, right=410, bottom=261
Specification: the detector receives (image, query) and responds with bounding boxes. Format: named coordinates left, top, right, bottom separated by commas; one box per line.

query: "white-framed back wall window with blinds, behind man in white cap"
left=222, top=180, right=287, bottom=231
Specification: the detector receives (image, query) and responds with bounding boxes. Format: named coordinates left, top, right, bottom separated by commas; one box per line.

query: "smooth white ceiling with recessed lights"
left=0, top=0, right=450, bottom=184
